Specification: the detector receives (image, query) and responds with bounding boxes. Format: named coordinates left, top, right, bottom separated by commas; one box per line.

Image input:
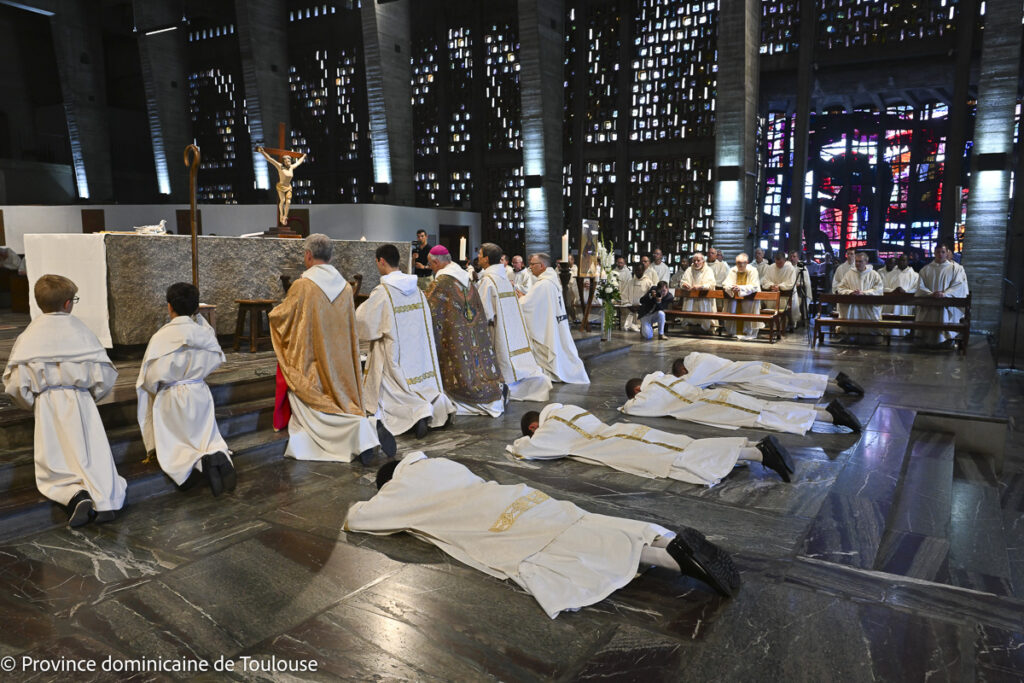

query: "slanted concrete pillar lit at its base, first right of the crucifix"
left=362, top=2, right=409, bottom=206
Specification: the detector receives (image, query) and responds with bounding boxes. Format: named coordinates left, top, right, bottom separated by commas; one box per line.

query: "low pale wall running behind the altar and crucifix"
left=0, top=204, right=480, bottom=254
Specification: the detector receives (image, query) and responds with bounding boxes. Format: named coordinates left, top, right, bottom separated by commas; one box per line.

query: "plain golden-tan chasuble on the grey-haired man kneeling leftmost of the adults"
left=269, top=278, right=366, bottom=418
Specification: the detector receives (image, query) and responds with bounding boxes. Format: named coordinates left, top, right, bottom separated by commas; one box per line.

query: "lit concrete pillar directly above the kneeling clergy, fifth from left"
left=517, top=0, right=565, bottom=254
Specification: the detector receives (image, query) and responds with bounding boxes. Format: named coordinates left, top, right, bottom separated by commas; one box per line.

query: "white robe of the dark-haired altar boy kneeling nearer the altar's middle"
left=135, top=315, right=230, bottom=484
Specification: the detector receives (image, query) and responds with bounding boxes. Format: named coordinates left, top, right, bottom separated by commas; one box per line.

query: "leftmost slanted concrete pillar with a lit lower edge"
left=50, top=2, right=112, bottom=202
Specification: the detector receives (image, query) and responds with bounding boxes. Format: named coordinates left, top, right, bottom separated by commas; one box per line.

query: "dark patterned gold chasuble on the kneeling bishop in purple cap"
left=427, top=273, right=502, bottom=403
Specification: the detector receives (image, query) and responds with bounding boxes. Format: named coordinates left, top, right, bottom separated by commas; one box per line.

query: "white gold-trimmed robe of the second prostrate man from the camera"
left=506, top=403, right=753, bottom=486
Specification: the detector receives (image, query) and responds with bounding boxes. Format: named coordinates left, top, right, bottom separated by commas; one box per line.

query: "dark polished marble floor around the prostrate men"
left=0, top=321, right=1024, bottom=681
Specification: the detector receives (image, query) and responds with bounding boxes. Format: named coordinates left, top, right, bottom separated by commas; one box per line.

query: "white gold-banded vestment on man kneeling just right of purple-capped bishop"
left=478, top=263, right=551, bottom=401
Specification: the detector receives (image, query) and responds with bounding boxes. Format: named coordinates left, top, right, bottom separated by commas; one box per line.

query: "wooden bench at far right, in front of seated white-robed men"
left=812, top=293, right=971, bottom=355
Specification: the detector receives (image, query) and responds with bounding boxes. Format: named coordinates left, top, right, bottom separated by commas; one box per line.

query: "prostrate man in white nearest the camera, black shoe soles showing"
left=344, top=453, right=740, bottom=618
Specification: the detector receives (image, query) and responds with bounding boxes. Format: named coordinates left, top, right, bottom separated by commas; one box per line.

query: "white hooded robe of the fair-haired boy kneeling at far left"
left=3, top=313, right=127, bottom=512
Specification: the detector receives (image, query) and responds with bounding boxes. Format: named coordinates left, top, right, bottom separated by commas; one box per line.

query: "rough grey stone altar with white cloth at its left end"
left=26, top=233, right=412, bottom=346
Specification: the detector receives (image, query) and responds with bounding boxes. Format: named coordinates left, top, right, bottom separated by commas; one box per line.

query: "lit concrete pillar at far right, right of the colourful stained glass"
left=963, top=2, right=1021, bottom=334
